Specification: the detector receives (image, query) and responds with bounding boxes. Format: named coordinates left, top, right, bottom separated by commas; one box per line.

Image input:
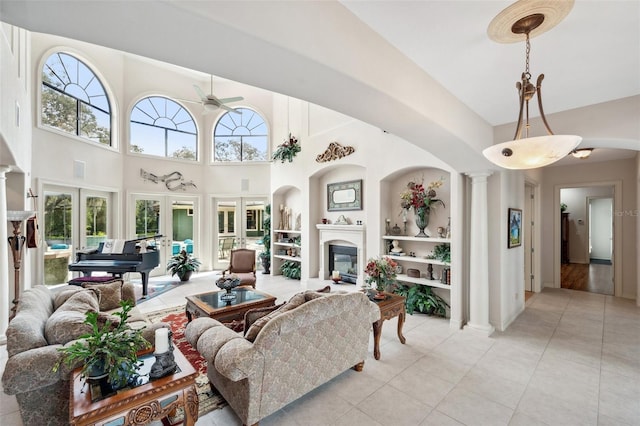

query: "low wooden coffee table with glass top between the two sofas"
left=185, top=286, right=276, bottom=322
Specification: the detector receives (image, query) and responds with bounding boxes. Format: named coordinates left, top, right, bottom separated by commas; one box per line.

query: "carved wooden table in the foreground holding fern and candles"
left=69, top=348, right=198, bottom=426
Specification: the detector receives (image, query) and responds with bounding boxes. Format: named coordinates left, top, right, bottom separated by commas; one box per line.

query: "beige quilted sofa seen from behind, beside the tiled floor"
left=185, top=291, right=380, bottom=425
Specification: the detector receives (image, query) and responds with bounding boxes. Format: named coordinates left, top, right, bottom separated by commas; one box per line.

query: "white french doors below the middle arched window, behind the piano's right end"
left=127, top=194, right=200, bottom=276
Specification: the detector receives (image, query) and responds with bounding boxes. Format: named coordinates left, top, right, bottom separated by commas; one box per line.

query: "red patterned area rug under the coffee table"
left=147, top=306, right=227, bottom=424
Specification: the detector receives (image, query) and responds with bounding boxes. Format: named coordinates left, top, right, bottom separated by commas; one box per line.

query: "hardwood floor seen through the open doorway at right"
left=560, top=263, right=613, bottom=296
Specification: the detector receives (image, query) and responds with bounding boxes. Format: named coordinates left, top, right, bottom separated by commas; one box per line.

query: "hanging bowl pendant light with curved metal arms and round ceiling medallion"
left=482, top=0, right=582, bottom=170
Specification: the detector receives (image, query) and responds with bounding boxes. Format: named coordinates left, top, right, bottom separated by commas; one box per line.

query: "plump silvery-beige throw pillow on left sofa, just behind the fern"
left=44, top=290, right=99, bottom=345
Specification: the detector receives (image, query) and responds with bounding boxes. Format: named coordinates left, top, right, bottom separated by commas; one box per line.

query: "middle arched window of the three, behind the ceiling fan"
left=129, top=96, right=198, bottom=161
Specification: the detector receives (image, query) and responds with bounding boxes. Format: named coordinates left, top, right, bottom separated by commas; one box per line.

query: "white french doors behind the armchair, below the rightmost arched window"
left=212, top=197, right=268, bottom=269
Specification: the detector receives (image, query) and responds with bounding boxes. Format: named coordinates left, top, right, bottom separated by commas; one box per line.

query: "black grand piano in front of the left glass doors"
left=69, top=235, right=162, bottom=297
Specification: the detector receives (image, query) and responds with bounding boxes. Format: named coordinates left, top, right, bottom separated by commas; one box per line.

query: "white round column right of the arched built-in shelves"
left=467, top=172, right=495, bottom=335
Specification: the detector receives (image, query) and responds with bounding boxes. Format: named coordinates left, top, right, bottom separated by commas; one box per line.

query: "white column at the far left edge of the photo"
left=0, top=165, right=11, bottom=344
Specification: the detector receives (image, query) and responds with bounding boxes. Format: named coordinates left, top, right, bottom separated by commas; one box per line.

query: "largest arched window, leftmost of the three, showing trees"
left=42, top=52, right=111, bottom=146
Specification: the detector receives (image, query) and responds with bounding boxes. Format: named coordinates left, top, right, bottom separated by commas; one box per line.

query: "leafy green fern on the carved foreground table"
left=53, top=300, right=151, bottom=388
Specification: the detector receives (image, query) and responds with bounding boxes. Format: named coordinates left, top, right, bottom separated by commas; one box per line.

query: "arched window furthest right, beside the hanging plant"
left=213, top=108, right=269, bottom=162
